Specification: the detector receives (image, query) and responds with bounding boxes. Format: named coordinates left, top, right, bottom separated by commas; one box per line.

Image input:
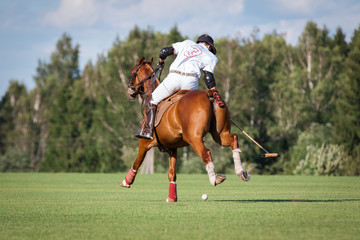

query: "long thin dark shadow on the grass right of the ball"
left=213, top=199, right=360, bottom=203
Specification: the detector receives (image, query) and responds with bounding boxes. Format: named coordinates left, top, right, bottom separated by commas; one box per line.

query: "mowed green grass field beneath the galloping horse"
left=0, top=173, right=360, bottom=239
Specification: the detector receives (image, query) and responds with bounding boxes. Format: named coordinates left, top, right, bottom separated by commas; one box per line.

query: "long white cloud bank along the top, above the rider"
left=43, top=0, right=244, bottom=28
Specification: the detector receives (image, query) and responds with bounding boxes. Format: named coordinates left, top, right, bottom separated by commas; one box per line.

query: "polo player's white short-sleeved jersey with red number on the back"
left=170, top=40, right=218, bottom=78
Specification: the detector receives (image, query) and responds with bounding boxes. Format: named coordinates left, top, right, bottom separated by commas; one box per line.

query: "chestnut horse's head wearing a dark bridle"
left=126, top=57, right=154, bottom=100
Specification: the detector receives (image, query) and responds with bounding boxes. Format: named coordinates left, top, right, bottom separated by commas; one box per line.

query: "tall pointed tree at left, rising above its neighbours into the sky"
left=35, top=34, right=80, bottom=171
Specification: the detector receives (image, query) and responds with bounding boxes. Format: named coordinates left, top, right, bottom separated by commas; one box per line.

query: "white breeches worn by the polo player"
left=151, top=73, right=199, bottom=105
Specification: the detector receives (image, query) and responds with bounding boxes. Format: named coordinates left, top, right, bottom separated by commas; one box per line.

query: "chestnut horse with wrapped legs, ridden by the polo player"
left=121, top=58, right=250, bottom=202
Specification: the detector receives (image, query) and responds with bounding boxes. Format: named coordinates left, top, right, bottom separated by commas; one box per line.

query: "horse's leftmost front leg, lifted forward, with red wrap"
left=120, top=139, right=151, bottom=188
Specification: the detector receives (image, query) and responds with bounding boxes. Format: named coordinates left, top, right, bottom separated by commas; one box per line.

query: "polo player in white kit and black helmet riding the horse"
left=135, top=34, right=224, bottom=139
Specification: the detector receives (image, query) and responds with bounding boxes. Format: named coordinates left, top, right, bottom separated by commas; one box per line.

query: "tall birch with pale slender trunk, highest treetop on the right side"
left=297, top=22, right=337, bottom=124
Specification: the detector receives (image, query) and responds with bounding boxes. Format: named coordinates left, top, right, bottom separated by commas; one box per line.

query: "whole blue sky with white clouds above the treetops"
left=0, top=0, right=360, bottom=97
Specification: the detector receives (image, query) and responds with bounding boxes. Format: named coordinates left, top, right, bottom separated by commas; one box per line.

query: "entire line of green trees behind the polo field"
left=0, top=22, right=360, bottom=175
